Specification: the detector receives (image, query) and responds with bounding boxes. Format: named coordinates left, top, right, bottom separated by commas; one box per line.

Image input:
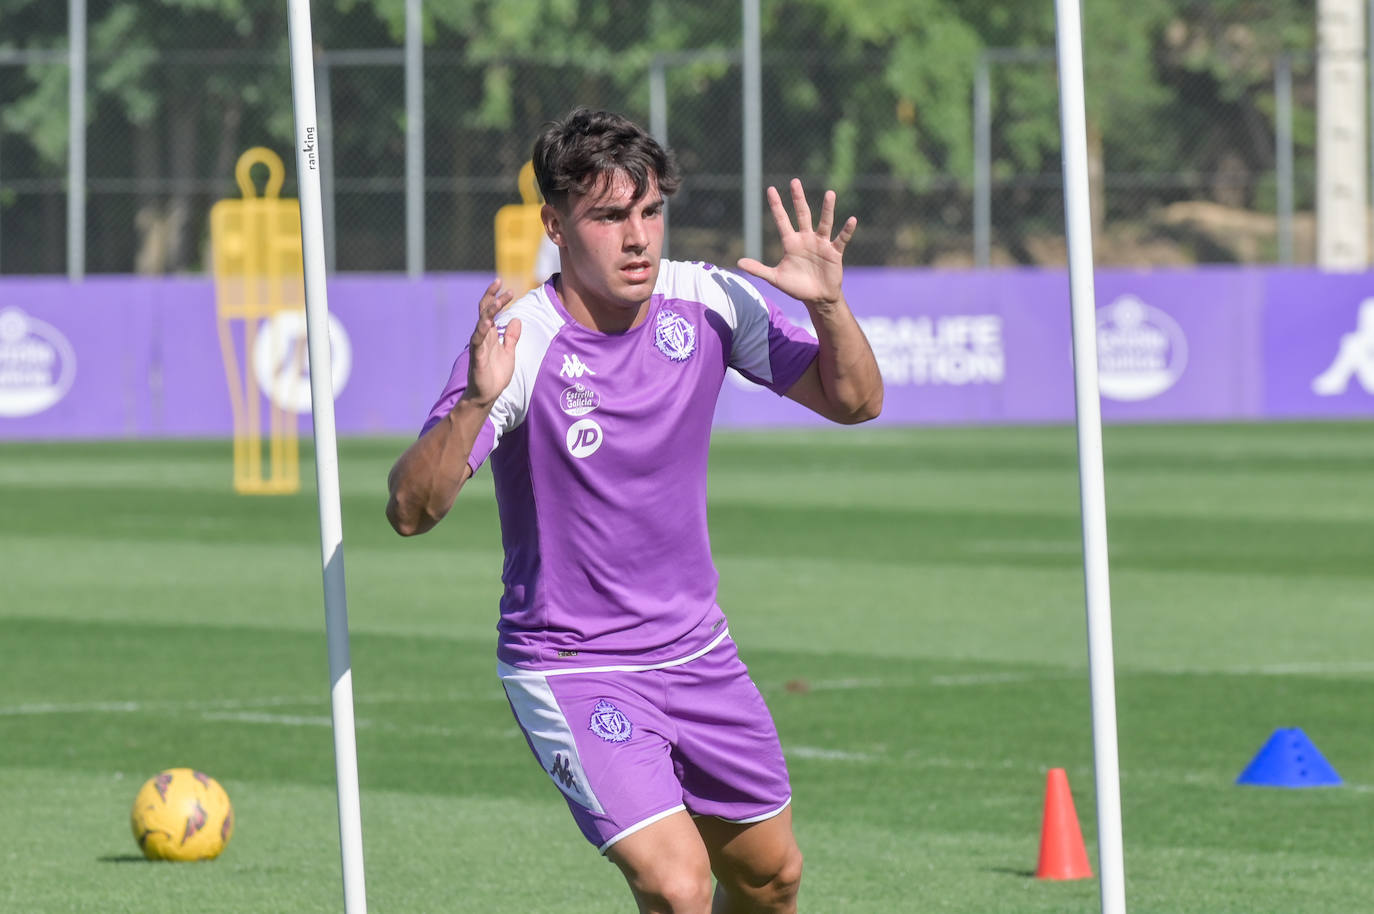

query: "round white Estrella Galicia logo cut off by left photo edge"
left=0, top=308, right=77, bottom=418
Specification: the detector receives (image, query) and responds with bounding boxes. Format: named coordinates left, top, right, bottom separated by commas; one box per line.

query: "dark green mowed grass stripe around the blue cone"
left=0, top=612, right=1374, bottom=855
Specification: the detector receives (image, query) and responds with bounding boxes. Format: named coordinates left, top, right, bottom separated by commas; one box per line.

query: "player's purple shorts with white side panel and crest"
left=500, top=632, right=791, bottom=854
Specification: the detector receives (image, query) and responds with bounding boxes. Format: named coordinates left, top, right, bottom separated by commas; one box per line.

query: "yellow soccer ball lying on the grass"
left=129, top=768, right=234, bottom=860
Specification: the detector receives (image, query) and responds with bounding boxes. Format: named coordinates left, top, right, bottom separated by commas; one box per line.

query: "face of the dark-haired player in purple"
left=550, top=172, right=664, bottom=330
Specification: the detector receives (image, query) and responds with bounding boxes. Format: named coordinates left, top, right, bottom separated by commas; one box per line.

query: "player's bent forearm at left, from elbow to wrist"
left=386, top=399, right=491, bottom=536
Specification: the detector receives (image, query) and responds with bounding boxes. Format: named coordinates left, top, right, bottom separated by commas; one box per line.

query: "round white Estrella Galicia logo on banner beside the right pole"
left=1098, top=296, right=1189, bottom=401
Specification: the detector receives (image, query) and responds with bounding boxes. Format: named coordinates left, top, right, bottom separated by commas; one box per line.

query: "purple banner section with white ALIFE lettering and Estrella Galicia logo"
left=717, top=269, right=1265, bottom=425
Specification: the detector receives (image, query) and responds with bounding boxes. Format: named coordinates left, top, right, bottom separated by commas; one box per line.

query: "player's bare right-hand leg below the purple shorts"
left=697, top=807, right=801, bottom=914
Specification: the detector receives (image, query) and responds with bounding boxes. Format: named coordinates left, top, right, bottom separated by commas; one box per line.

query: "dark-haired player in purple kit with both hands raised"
left=386, top=109, right=882, bottom=914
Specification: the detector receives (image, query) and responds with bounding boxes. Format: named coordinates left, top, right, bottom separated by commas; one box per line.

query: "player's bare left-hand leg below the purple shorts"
left=606, top=812, right=712, bottom=914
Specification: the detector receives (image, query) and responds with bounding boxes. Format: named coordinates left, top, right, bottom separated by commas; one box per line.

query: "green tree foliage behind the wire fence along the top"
left=0, top=0, right=1315, bottom=267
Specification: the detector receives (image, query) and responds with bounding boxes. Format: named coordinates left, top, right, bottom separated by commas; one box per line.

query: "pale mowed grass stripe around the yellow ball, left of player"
left=0, top=768, right=625, bottom=914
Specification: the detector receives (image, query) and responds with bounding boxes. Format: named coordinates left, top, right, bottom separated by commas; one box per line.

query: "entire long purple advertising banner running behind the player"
left=0, top=268, right=1374, bottom=440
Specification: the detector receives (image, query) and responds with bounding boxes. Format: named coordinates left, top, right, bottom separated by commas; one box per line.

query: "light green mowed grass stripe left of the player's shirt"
left=0, top=533, right=502, bottom=645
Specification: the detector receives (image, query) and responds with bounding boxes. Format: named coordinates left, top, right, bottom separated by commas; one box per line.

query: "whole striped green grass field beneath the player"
left=0, top=423, right=1374, bottom=914
